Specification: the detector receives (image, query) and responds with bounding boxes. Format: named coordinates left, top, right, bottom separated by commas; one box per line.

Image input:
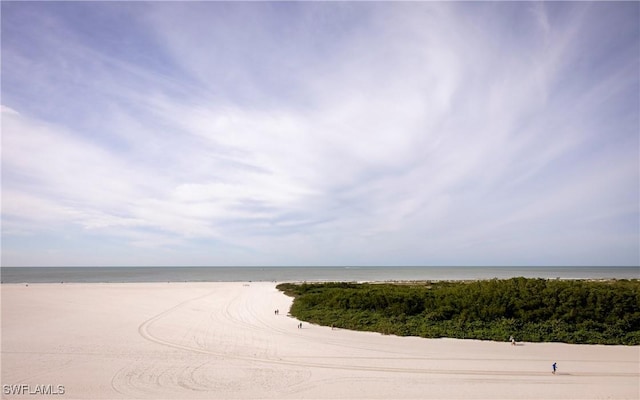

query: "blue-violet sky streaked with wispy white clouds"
left=1, top=1, right=640, bottom=266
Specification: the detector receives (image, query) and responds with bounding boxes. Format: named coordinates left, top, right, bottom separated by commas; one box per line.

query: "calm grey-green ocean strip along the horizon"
left=0, top=267, right=640, bottom=283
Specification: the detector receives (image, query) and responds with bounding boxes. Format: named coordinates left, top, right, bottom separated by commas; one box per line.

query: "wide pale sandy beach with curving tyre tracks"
left=0, top=283, right=640, bottom=399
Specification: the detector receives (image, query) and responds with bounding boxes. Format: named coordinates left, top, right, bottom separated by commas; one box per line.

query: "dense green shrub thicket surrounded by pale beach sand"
left=278, top=278, right=640, bottom=345
